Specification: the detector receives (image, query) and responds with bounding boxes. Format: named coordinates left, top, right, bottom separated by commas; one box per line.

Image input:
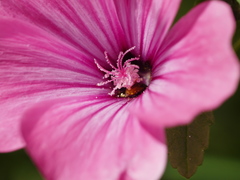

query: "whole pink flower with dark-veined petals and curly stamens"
left=0, top=0, right=239, bottom=180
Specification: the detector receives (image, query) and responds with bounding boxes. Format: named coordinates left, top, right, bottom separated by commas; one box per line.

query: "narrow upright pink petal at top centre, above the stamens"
left=114, top=0, right=181, bottom=60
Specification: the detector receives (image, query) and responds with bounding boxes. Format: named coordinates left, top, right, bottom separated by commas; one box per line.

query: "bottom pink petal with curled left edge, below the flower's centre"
left=22, top=97, right=167, bottom=180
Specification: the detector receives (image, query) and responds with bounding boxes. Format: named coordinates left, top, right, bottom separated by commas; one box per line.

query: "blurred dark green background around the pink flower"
left=0, top=0, right=240, bottom=180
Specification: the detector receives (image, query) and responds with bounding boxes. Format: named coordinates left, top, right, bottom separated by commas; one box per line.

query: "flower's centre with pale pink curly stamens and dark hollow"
left=94, top=47, right=151, bottom=97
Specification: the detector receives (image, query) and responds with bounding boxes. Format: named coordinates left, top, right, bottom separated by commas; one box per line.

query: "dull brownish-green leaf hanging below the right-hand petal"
left=166, top=112, right=214, bottom=178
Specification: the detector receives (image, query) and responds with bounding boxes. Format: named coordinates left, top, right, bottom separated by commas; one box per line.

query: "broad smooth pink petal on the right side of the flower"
left=132, top=1, right=239, bottom=126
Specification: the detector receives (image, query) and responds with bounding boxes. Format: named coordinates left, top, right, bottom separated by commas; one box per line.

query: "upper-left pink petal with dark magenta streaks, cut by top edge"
left=0, top=0, right=125, bottom=58
